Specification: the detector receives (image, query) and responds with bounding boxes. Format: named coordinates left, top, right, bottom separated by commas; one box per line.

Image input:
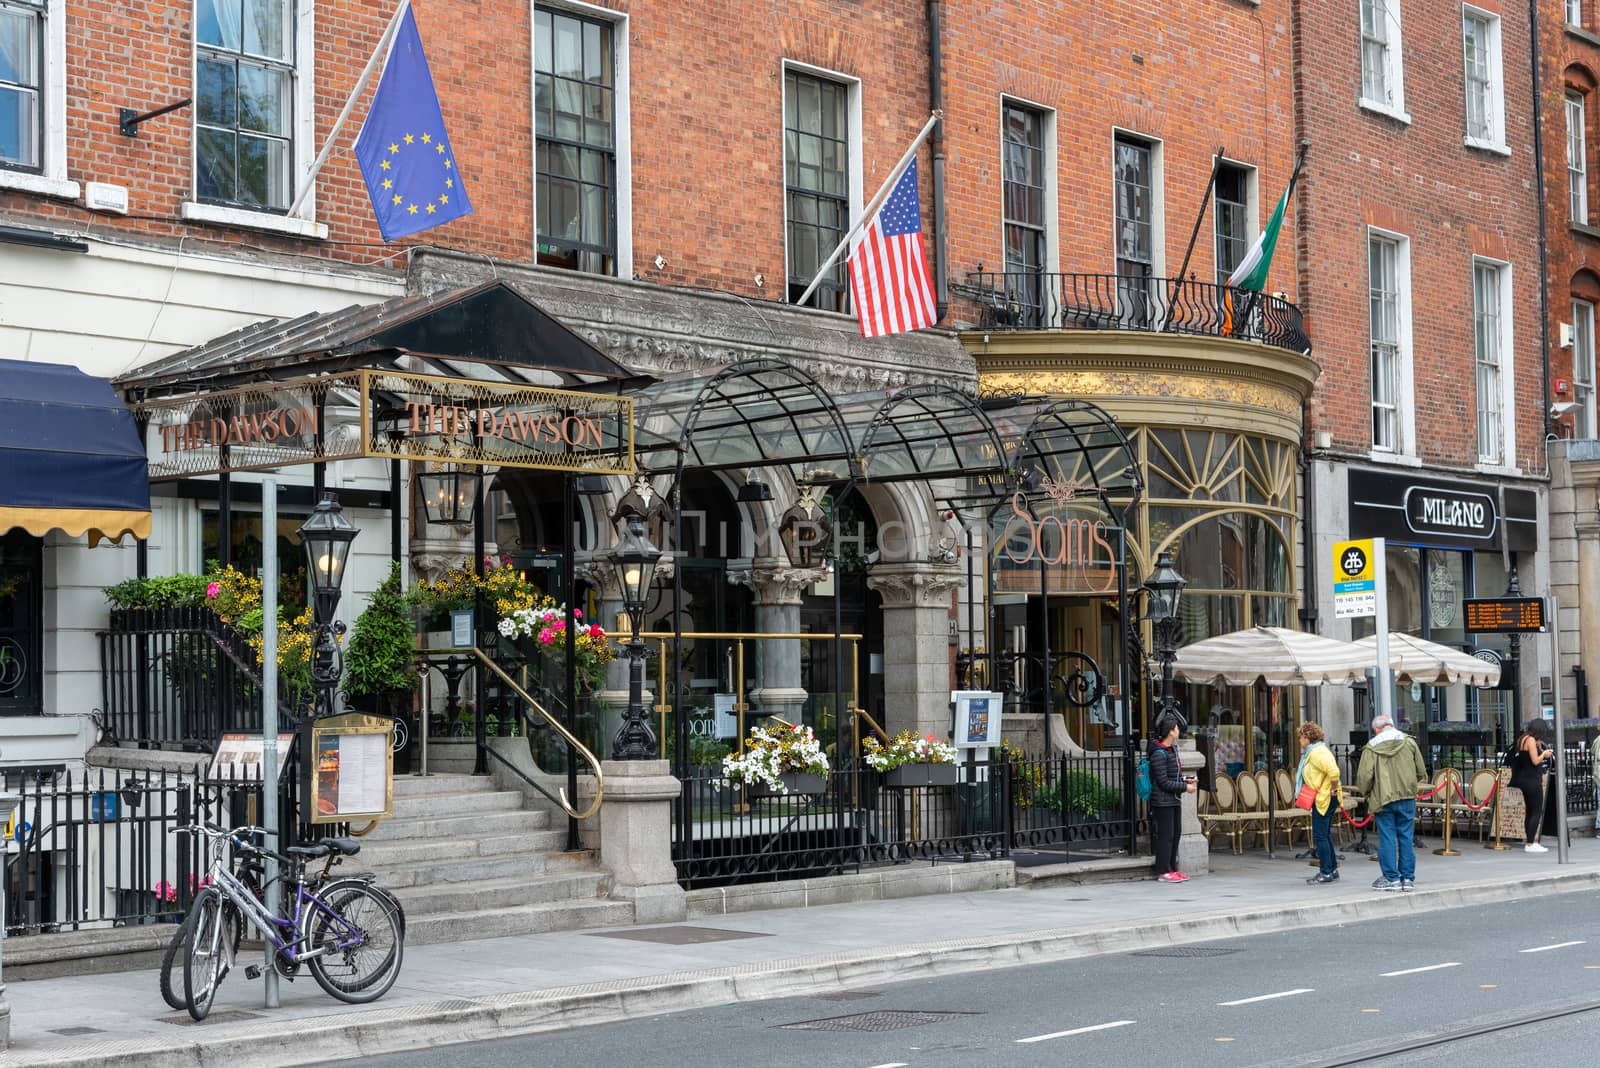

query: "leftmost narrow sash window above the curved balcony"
left=1000, top=101, right=1051, bottom=326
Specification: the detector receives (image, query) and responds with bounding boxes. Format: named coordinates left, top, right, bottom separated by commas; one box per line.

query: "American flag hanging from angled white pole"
left=850, top=160, right=939, bottom=337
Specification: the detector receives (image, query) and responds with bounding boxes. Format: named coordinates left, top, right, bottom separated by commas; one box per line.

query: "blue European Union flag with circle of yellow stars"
left=355, top=6, right=472, bottom=241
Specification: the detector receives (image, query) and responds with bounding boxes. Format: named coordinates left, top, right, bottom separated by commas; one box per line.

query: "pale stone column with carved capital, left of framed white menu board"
left=867, top=563, right=966, bottom=737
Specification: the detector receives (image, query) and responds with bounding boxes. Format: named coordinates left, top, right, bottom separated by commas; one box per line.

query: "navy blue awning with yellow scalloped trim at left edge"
left=0, top=360, right=150, bottom=544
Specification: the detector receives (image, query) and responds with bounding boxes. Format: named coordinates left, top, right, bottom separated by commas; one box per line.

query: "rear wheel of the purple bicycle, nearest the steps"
left=302, top=883, right=405, bottom=1004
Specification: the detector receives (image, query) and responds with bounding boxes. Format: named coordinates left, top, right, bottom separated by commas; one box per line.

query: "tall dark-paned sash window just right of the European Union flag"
left=533, top=6, right=618, bottom=275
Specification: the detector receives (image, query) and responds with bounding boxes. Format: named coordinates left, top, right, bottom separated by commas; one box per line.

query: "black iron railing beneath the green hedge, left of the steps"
left=99, top=608, right=305, bottom=751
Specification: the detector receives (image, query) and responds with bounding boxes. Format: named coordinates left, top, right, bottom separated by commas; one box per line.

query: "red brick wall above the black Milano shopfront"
left=1296, top=0, right=1544, bottom=472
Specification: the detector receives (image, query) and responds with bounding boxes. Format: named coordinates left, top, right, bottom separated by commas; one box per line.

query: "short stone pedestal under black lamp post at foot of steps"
left=579, top=759, right=688, bottom=924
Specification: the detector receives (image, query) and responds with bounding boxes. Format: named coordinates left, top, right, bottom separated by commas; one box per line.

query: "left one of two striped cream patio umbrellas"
left=1173, top=627, right=1382, bottom=686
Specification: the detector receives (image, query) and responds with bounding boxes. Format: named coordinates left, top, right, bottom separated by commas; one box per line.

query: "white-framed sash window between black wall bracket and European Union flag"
left=195, top=0, right=304, bottom=211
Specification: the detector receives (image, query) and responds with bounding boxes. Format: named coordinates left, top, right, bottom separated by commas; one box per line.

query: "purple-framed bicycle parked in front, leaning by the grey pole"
left=179, top=823, right=405, bottom=1020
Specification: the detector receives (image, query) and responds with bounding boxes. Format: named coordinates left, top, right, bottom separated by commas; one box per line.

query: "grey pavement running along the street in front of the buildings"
left=5, top=838, right=1600, bottom=1068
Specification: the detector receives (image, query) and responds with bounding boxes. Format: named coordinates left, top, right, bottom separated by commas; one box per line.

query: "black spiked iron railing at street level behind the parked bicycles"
left=3, top=767, right=334, bottom=935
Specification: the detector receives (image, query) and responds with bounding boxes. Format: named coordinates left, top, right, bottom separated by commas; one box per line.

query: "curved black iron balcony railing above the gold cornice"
left=950, top=270, right=1310, bottom=352
